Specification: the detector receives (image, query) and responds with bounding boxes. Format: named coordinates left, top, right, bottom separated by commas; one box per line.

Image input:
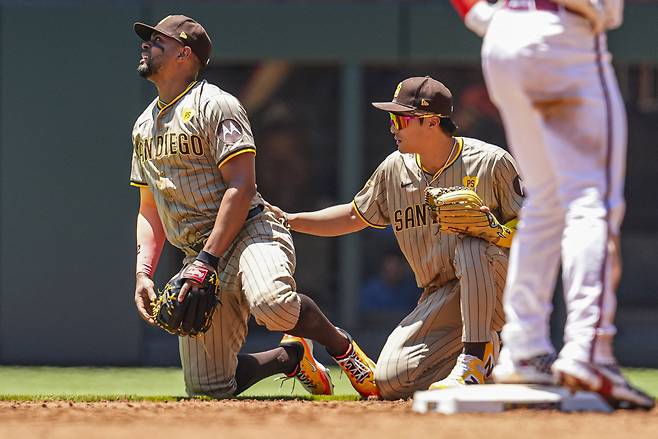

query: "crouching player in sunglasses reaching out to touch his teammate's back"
left=271, top=77, right=523, bottom=398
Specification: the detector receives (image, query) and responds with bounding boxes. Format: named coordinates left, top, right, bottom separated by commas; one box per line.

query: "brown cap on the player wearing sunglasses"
left=372, top=76, right=452, bottom=117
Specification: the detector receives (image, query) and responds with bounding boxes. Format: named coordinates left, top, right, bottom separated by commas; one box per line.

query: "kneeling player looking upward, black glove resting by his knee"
left=131, top=15, right=377, bottom=397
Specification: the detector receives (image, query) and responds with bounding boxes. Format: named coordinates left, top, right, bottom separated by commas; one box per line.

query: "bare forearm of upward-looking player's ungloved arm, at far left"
left=135, top=188, right=165, bottom=277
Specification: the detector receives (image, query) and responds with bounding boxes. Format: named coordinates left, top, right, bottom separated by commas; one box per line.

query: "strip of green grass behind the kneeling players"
left=0, top=366, right=658, bottom=402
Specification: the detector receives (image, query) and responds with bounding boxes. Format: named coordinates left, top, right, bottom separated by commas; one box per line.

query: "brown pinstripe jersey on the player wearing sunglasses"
left=353, top=137, right=523, bottom=288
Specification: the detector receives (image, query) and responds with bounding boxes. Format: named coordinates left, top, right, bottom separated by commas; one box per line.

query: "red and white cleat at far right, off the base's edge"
left=553, top=358, right=656, bottom=410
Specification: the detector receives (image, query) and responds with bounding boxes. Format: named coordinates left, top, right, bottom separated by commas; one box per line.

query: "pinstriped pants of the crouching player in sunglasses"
left=375, top=237, right=507, bottom=399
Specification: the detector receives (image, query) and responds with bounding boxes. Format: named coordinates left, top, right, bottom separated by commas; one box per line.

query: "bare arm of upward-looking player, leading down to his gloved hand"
left=203, top=153, right=256, bottom=256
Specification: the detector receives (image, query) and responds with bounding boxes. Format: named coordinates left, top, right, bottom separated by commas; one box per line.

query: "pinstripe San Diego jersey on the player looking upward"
left=130, top=81, right=263, bottom=256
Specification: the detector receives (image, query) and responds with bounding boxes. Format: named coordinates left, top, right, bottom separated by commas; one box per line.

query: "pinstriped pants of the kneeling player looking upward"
left=179, top=212, right=300, bottom=397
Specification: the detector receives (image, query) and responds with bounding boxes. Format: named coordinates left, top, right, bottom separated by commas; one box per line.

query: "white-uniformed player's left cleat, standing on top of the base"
left=492, top=348, right=557, bottom=385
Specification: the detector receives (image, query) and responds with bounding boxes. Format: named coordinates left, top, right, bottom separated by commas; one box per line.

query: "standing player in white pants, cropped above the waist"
left=453, top=0, right=654, bottom=408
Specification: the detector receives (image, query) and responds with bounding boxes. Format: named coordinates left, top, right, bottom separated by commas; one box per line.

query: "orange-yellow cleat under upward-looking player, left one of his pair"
left=279, top=334, right=334, bottom=395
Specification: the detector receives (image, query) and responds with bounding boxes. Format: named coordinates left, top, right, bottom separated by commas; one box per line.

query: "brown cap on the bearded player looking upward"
left=133, top=15, right=212, bottom=66
